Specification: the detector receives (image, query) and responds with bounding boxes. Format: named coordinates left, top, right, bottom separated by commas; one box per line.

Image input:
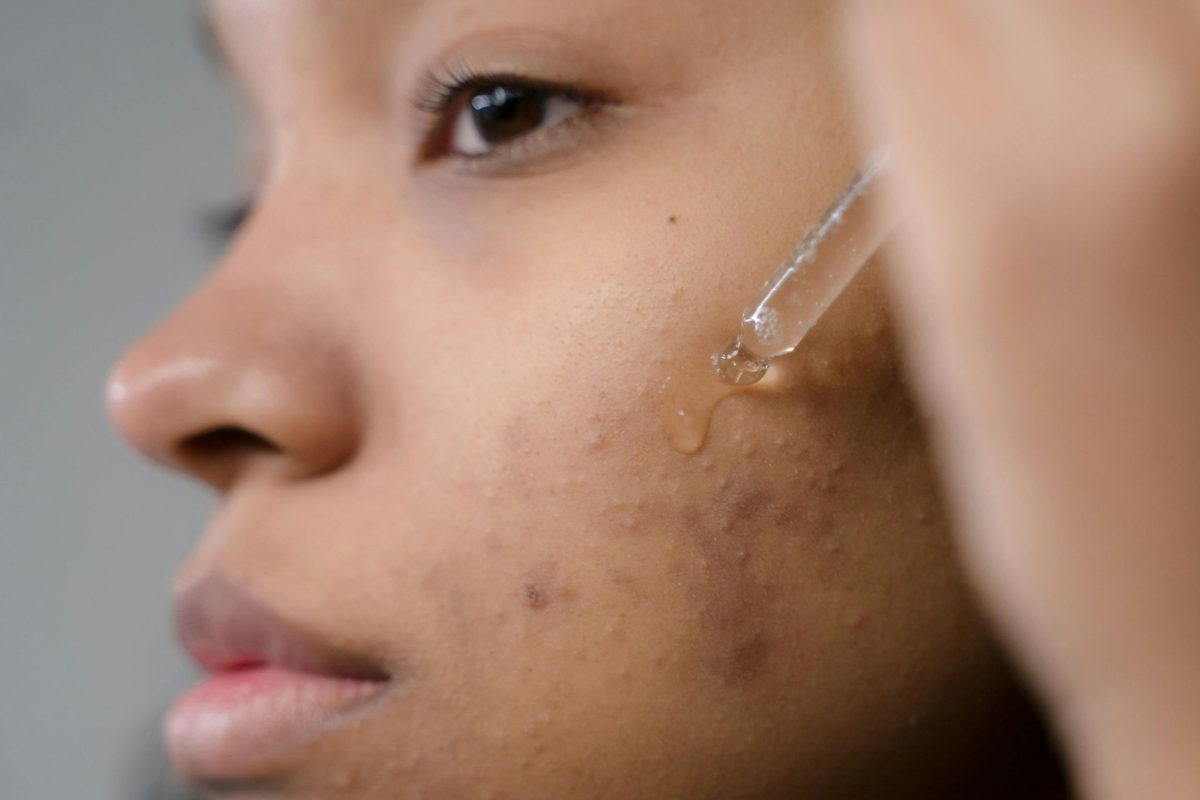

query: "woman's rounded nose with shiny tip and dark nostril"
left=107, top=262, right=359, bottom=491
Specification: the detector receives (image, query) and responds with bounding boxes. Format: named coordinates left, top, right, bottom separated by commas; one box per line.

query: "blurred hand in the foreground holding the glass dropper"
left=851, top=0, right=1200, bottom=800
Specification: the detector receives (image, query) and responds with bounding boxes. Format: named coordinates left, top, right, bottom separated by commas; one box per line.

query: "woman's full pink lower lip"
left=166, top=666, right=386, bottom=780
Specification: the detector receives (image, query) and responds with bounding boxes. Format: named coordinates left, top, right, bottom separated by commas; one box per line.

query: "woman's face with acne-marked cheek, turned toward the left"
left=109, top=0, right=1008, bottom=799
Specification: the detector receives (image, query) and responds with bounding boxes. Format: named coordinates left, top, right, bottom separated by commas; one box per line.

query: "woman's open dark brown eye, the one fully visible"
left=418, top=72, right=611, bottom=172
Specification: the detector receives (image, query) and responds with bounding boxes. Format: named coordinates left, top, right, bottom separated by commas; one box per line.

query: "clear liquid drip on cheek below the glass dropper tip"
left=659, top=343, right=768, bottom=456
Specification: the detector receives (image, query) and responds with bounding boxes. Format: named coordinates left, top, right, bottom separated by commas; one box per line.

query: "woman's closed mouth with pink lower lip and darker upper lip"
left=164, top=573, right=392, bottom=782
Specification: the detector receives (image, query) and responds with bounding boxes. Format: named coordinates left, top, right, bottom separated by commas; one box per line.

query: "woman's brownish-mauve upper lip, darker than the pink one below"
left=175, top=572, right=389, bottom=681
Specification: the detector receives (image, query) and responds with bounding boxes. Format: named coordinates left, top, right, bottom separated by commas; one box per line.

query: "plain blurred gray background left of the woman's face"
left=0, top=0, right=240, bottom=800
